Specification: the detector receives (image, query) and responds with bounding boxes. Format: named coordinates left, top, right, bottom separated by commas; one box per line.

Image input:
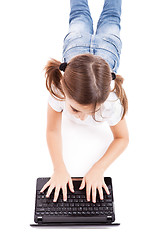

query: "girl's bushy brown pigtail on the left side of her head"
left=44, top=58, right=64, bottom=100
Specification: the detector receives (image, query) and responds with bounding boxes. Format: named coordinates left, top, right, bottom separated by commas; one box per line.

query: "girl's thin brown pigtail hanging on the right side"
left=112, top=75, right=128, bottom=119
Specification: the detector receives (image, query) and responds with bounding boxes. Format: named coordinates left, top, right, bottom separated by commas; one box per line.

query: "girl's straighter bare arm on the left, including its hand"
left=41, top=104, right=74, bottom=202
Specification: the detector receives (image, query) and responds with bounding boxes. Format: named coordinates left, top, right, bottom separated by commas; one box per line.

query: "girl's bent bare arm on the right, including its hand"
left=79, top=118, right=129, bottom=202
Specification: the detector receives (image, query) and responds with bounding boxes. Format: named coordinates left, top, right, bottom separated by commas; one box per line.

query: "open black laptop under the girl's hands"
left=30, top=177, right=120, bottom=227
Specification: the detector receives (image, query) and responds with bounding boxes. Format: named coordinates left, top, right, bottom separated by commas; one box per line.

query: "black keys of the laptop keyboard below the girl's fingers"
left=35, top=185, right=114, bottom=219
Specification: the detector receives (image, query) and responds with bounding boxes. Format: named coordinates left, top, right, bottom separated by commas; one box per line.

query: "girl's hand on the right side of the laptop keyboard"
left=79, top=164, right=110, bottom=202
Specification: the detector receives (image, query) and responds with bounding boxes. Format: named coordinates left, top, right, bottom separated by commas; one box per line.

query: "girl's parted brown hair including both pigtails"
left=44, top=53, right=128, bottom=121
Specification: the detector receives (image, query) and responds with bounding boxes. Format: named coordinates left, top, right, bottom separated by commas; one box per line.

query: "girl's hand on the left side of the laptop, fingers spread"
left=40, top=167, right=74, bottom=202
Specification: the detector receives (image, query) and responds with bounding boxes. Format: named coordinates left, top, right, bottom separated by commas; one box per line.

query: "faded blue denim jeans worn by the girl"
left=62, top=0, right=122, bottom=73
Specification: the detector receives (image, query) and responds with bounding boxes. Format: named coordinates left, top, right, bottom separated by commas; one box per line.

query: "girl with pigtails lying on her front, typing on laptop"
left=41, top=0, right=129, bottom=202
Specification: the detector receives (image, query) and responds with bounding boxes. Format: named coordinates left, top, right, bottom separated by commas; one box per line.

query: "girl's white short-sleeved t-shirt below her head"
left=48, top=92, right=124, bottom=126
